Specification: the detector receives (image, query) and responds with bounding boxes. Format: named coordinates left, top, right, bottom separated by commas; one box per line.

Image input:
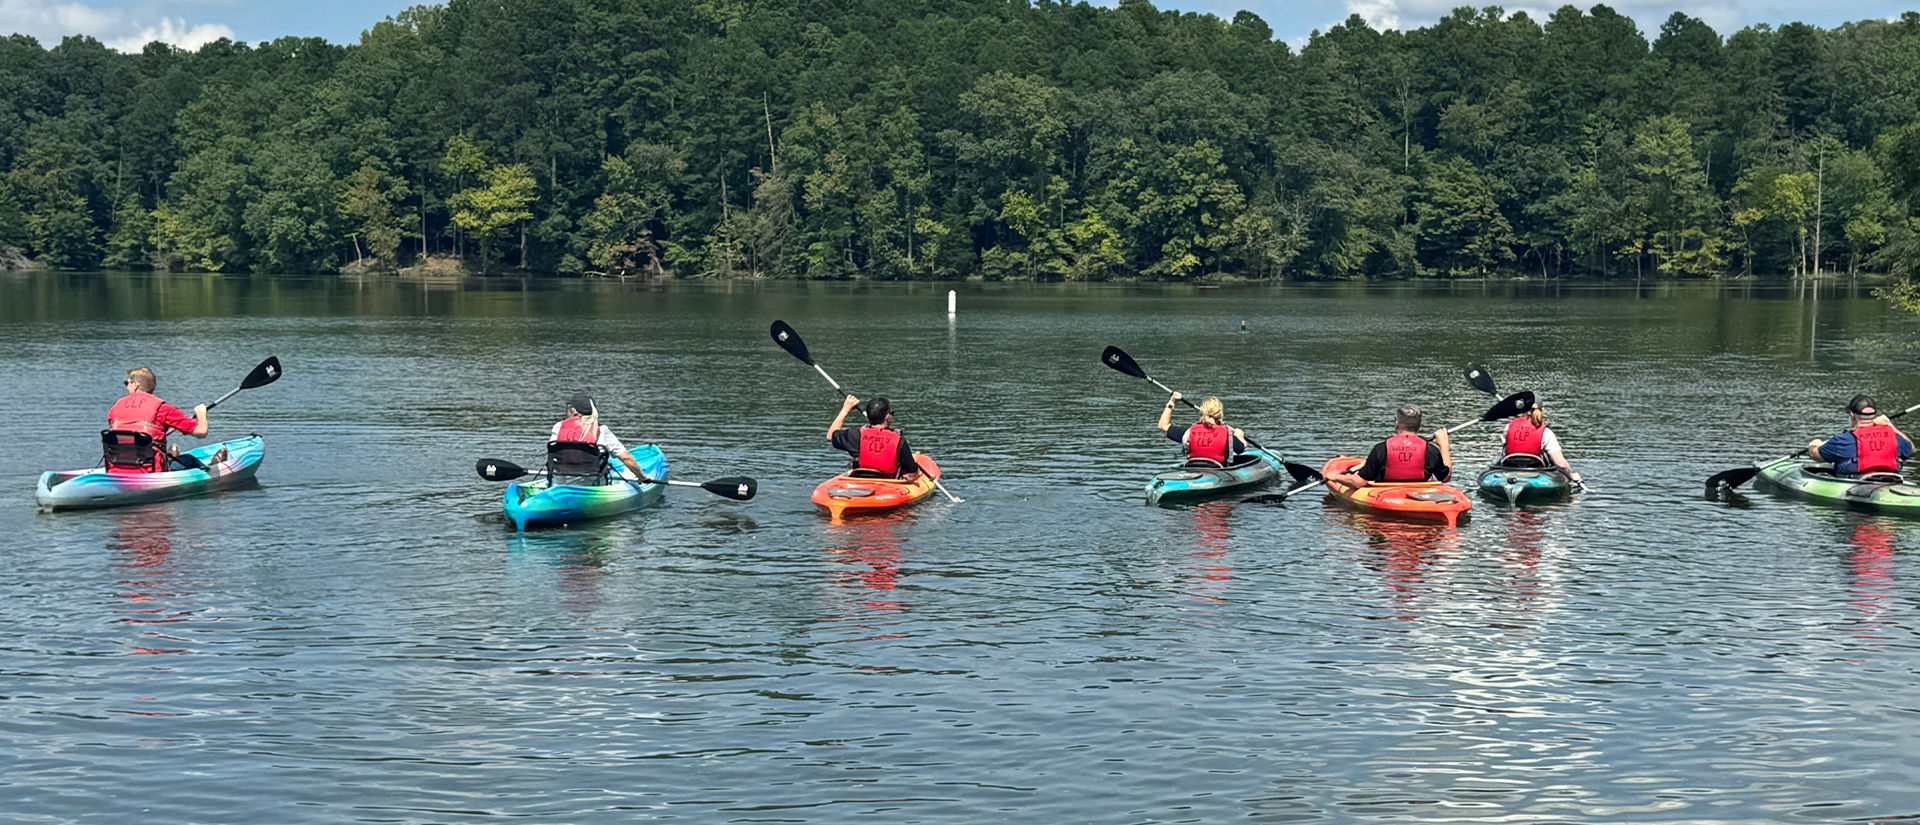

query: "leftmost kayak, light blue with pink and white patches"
left=33, top=436, right=267, bottom=510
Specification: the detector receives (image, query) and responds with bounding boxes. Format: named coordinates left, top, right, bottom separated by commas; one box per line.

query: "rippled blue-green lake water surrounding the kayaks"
left=0, top=274, right=1920, bottom=823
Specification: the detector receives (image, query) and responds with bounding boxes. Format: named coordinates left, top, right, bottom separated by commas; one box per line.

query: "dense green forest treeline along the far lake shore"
left=0, top=0, right=1920, bottom=280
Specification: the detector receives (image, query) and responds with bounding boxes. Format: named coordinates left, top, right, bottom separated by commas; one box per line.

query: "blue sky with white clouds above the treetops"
left=0, top=0, right=1920, bottom=50
